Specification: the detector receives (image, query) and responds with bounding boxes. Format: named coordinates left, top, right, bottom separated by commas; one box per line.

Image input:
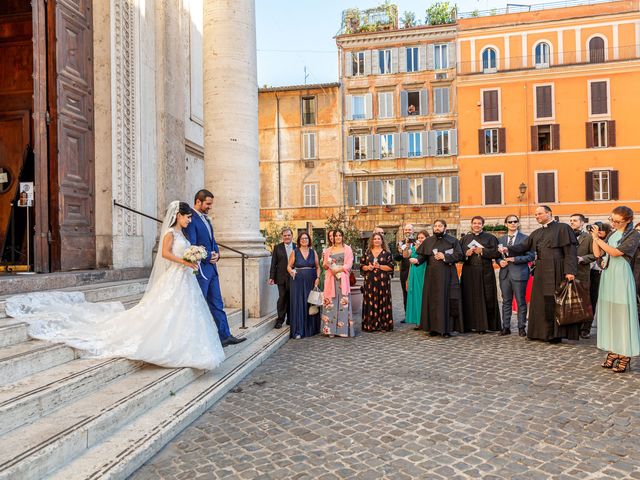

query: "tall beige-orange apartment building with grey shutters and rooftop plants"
left=336, top=17, right=459, bottom=240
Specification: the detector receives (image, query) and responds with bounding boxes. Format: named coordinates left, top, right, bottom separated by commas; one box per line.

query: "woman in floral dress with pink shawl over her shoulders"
left=321, top=230, right=355, bottom=337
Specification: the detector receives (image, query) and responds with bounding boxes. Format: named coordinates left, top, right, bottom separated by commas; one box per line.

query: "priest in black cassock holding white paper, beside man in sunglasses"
left=460, top=216, right=501, bottom=333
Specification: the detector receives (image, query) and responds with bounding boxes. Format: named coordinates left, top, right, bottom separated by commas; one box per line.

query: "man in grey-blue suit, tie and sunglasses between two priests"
left=498, top=215, right=535, bottom=337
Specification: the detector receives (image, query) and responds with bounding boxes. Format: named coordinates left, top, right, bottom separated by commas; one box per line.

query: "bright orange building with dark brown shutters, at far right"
left=457, top=0, right=640, bottom=229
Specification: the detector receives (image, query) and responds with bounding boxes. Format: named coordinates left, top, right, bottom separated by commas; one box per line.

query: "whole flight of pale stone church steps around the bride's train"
left=0, top=272, right=288, bottom=479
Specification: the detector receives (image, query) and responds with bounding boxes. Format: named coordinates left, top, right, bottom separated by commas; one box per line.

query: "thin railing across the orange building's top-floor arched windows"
left=458, top=45, right=640, bottom=75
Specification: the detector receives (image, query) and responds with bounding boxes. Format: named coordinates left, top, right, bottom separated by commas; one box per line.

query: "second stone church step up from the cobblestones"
left=0, top=365, right=202, bottom=479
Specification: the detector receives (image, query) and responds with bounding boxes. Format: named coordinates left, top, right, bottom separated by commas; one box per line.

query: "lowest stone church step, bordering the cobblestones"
left=51, top=328, right=289, bottom=480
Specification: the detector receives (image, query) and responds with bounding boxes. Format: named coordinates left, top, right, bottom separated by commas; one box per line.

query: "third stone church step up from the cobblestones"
left=0, top=358, right=144, bottom=435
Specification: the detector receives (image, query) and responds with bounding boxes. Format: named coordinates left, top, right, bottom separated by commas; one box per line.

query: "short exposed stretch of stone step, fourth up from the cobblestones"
left=0, top=340, right=77, bottom=386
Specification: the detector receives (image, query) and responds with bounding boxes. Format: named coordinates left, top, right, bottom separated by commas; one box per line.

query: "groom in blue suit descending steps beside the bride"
left=184, top=189, right=246, bottom=347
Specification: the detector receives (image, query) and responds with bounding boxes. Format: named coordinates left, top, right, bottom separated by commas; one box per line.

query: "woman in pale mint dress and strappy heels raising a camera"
left=591, top=207, right=640, bottom=373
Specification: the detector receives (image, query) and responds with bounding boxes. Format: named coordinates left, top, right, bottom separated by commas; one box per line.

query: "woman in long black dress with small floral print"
left=360, top=233, right=393, bottom=332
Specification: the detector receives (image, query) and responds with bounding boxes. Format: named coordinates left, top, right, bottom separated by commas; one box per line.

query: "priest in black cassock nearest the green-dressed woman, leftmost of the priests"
left=410, top=220, right=463, bottom=337
